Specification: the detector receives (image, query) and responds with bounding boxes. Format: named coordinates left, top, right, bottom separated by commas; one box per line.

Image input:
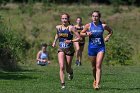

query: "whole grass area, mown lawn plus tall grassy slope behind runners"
left=0, top=4, right=140, bottom=93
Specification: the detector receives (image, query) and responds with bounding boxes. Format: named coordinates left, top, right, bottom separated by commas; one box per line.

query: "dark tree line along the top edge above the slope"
left=0, top=0, right=140, bottom=6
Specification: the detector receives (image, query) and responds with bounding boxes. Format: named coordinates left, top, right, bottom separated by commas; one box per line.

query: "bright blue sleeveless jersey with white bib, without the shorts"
left=88, top=22, right=105, bottom=48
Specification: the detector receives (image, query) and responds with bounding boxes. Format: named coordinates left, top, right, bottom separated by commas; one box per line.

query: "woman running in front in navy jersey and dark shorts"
left=52, top=13, right=80, bottom=89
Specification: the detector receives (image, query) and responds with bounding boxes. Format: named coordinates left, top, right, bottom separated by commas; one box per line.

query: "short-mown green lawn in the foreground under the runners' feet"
left=0, top=63, right=140, bottom=93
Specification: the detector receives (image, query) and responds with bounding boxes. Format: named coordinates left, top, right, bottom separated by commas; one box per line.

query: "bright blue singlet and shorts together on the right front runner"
left=88, top=22, right=105, bottom=56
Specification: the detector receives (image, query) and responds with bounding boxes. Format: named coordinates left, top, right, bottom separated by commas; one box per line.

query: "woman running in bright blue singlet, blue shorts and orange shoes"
left=80, top=11, right=112, bottom=89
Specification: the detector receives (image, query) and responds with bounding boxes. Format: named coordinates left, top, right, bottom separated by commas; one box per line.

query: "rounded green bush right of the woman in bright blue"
left=105, top=34, right=133, bottom=65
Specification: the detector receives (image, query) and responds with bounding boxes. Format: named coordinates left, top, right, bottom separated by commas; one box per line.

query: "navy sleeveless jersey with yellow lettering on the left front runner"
left=57, top=26, right=73, bottom=48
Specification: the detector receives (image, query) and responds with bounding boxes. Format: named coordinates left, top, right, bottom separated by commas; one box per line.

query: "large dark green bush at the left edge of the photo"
left=0, top=16, right=29, bottom=70
